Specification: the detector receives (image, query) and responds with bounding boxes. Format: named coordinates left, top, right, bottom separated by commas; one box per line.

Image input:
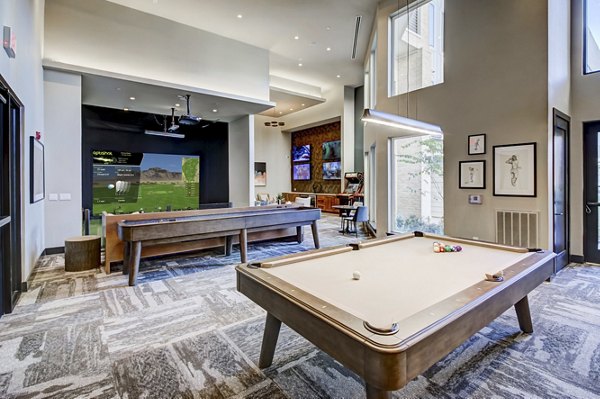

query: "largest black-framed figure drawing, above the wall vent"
left=494, top=143, right=537, bottom=197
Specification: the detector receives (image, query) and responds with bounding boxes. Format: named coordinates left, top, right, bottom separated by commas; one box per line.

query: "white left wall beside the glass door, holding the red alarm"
left=0, top=0, right=47, bottom=281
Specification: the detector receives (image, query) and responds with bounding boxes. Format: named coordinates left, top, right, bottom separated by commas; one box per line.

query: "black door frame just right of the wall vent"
left=552, top=108, right=571, bottom=273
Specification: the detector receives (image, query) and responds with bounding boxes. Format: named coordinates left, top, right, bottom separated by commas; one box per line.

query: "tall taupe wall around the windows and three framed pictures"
left=364, top=0, right=550, bottom=247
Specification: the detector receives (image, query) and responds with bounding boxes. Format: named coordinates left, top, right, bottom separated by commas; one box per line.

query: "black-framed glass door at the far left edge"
left=0, top=76, right=22, bottom=315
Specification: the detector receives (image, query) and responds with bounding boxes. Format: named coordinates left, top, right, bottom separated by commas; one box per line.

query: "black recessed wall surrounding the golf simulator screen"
left=81, top=105, right=229, bottom=209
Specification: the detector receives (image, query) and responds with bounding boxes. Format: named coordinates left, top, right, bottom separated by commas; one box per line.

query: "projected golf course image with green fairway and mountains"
left=92, top=151, right=200, bottom=216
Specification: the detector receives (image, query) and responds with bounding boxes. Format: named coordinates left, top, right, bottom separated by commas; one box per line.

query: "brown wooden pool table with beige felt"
left=236, top=232, right=554, bottom=399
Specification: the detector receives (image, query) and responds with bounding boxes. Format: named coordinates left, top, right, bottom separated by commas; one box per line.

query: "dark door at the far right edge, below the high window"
left=583, top=121, right=600, bottom=263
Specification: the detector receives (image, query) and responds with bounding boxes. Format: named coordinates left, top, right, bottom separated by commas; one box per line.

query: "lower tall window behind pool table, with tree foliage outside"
left=390, top=136, right=444, bottom=234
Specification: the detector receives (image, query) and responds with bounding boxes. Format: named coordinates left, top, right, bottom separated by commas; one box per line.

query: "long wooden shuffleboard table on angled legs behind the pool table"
left=117, top=205, right=321, bottom=286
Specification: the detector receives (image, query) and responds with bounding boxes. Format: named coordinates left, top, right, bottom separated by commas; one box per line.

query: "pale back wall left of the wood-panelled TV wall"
left=254, top=115, right=292, bottom=197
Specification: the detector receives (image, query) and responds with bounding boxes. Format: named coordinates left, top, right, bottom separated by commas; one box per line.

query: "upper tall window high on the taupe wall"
left=389, top=0, right=444, bottom=96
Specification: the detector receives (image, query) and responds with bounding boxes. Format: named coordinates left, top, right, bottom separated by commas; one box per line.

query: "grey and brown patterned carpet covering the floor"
left=0, top=217, right=600, bottom=399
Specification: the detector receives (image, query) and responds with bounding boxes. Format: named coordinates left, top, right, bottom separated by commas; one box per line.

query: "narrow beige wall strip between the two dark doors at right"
left=570, top=0, right=600, bottom=255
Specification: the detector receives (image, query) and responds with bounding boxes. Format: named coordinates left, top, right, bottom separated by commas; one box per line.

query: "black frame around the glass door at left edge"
left=0, top=75, right=24, bottom=314
